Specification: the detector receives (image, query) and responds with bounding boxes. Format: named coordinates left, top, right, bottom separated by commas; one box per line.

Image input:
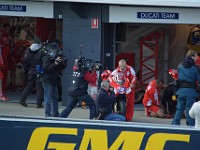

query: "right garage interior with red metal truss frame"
left=111, top=23, right=199, bottom=85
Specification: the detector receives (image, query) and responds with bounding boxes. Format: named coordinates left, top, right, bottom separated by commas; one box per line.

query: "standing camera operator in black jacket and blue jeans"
left=42, top=43, right=67, bottom=117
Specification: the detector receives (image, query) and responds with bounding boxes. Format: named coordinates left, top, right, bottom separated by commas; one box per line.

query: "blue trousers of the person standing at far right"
left=172, top=95, right=196, bottom=126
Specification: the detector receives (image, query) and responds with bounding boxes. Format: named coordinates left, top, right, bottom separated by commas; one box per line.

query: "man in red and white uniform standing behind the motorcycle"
left=109, top=59, right=137, bottom=121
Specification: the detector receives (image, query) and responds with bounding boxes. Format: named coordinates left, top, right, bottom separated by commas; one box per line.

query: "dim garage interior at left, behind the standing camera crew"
left=0, top=16, right=62, bottom=92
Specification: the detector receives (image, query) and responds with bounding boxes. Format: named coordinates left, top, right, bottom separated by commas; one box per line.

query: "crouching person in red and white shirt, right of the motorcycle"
left=143, top=80, right=166, bottom=118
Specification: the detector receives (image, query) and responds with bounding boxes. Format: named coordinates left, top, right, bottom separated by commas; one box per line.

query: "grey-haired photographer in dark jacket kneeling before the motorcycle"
left=97, top=81, right=125, bottom=121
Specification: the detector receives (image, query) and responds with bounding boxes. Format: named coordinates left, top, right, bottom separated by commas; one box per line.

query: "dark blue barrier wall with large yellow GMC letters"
left=0, top=116, right=200, bottom=150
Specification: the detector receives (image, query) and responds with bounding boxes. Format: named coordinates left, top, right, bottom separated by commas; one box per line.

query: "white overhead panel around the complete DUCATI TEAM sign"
left=109, top=6, right=200, bottom=24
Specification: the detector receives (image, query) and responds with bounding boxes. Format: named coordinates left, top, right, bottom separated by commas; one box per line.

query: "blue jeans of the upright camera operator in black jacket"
left=43, top=82, right=59, bottom=117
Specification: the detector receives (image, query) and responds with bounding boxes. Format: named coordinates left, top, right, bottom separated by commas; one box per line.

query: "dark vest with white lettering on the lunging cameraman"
left=68, top=71, right=88, bottom=96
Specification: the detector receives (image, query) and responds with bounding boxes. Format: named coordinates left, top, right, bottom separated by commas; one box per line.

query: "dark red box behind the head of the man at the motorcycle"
left=115, top=53, right=135, bottom=67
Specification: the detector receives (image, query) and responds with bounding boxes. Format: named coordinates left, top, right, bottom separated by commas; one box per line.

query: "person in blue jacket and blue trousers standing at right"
left=172, top=50, right=200, bottom=126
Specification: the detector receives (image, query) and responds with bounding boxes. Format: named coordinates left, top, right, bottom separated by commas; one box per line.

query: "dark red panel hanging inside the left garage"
left=35, top=18, right=56, bottom=42
